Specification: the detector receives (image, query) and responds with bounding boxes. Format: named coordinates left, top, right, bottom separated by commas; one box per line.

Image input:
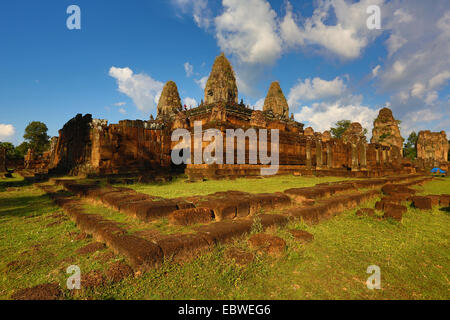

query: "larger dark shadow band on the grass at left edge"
left=0, top=195, right=55, bottom=219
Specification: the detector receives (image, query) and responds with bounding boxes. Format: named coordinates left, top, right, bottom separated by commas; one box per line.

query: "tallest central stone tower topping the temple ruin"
left=205, top=53, right=238, bottom=104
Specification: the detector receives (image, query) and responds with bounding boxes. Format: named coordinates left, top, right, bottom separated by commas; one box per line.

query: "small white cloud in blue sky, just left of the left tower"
left=109, top=67, right=164, bottom=113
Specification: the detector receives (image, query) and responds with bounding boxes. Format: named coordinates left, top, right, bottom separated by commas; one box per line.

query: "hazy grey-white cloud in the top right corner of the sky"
left=378, top=0, right=450, bottom=111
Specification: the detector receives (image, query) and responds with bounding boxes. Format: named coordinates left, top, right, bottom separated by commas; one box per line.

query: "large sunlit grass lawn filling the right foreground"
left=95, top=191, right=450, bottom=299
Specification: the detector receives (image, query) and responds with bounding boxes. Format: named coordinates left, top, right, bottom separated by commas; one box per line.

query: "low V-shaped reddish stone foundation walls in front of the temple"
left=36, top=175, right=432, bottom=271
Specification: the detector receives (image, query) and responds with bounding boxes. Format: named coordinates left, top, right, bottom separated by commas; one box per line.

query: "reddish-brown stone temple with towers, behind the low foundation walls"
left=25, top=54, right=448, bottom=180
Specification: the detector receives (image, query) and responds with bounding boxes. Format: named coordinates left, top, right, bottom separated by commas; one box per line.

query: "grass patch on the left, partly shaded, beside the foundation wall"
left=0, top=186, right=125, bottom=299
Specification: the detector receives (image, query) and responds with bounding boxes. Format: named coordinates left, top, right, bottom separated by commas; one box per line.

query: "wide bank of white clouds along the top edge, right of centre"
left=172, top=0, right=382, bottom=64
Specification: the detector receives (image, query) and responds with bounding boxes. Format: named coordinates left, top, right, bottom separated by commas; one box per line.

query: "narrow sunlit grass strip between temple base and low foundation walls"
left=118, top=175, right=354, bottom=198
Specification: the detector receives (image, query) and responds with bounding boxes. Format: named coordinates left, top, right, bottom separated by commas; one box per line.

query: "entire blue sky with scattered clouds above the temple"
left=0, top=0, right=450, bottom=144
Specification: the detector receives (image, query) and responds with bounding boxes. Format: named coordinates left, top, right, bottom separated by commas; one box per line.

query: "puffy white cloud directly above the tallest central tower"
left=214, top=0, right=281, bottom=64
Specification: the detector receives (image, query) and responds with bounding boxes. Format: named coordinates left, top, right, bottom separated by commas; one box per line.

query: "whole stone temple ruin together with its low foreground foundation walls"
left=5, top=55, right=450, bottom=282
